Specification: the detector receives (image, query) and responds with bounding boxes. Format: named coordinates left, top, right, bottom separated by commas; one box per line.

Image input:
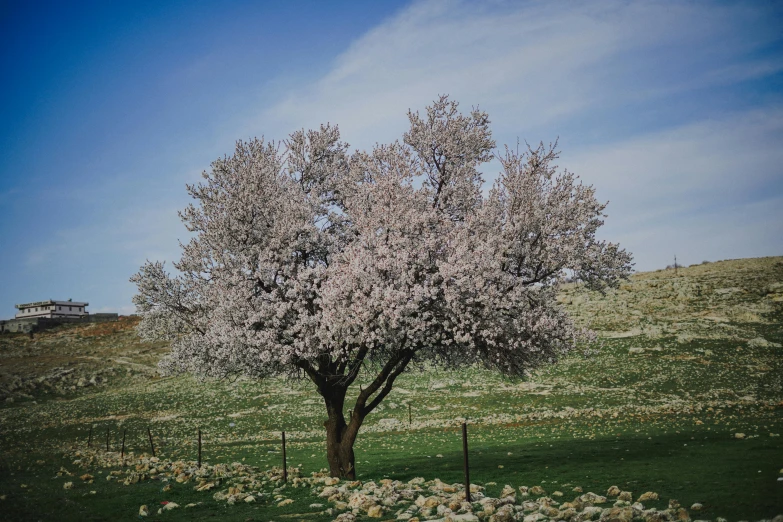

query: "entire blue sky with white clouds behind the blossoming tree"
left=0, top=0, right=783, bottom=312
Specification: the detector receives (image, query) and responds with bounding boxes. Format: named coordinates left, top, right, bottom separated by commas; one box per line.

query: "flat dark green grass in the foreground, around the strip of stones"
left=3, top=412, right=783, bottom=520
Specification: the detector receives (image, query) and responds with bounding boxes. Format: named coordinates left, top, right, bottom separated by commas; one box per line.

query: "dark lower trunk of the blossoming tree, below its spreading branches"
left=324, top=390, right=361, bottom=480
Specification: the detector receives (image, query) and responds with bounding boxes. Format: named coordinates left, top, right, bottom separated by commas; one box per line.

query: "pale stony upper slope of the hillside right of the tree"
left=558, top=257, right=783, bottom=342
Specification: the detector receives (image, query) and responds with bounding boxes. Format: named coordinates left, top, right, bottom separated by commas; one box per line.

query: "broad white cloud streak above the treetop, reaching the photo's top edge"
left=254, top=0, right=780, bottom=148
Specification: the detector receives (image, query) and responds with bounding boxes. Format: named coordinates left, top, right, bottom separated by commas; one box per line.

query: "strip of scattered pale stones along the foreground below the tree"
left=57, top=449, right=772, bottom=522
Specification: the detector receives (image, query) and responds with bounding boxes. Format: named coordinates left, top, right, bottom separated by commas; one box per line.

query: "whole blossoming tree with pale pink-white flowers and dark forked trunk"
left=131, top=96, right=631, bottom=478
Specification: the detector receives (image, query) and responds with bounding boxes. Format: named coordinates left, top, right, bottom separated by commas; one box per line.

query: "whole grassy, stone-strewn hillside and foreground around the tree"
left=0, top=258, right=783, bottom=522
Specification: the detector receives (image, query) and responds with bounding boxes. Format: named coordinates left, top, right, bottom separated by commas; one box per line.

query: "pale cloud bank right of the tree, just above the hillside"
left=563, top=107, right=783, bottom=270
